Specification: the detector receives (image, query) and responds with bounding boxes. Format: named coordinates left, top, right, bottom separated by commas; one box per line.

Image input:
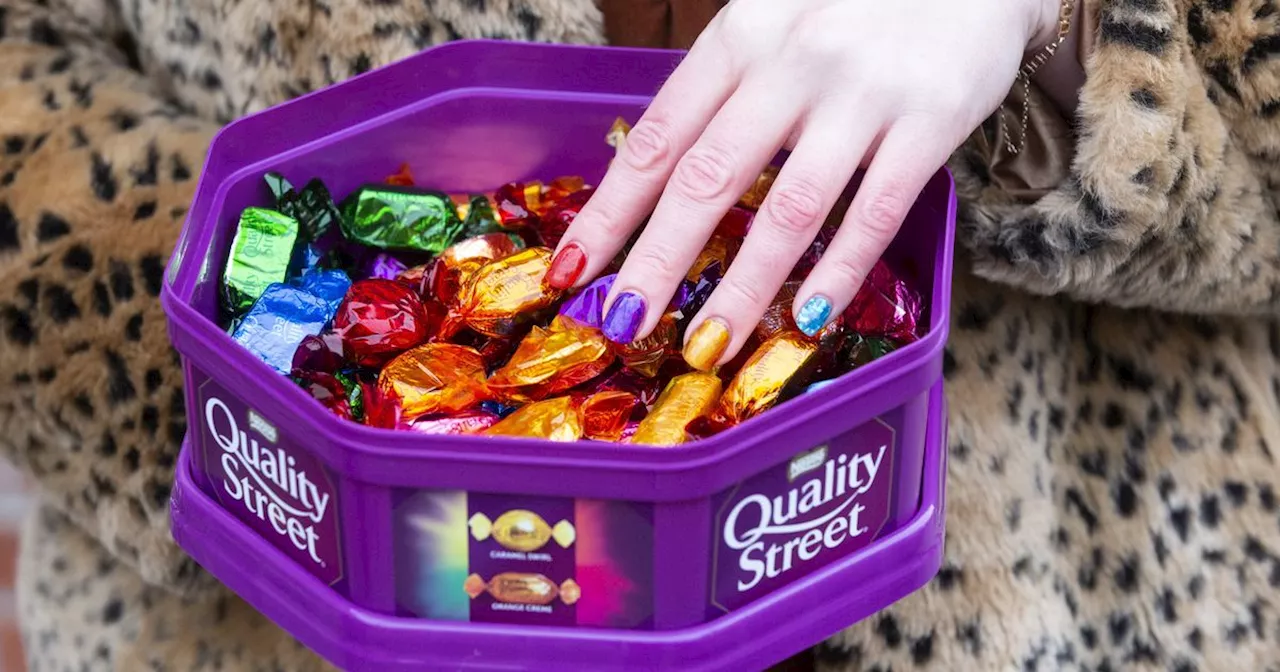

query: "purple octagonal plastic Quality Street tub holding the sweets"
left=161, top=42, right=955, bottom=669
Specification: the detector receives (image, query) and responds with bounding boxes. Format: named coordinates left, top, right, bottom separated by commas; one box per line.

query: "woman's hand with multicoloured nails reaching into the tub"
left=548, top=0, right=1060, bottom=369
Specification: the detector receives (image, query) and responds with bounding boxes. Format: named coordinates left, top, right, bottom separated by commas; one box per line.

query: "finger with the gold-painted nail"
left=685, top=112, right=879, bottom=370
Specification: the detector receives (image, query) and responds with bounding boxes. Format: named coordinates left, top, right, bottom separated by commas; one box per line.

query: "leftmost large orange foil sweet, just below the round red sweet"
left=378, top=343, right=485, bottom=420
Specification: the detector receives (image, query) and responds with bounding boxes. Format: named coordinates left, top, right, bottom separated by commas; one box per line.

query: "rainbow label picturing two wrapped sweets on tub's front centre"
left=394, top=490, right=653, bottom=628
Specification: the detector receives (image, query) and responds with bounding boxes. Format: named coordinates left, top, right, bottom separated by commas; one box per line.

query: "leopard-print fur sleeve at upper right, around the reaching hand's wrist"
left=952, top=0, right=1280, bottom=314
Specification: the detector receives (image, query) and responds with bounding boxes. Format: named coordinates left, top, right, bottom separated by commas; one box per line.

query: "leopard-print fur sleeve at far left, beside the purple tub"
left=0, top=0, right=214, bottom=588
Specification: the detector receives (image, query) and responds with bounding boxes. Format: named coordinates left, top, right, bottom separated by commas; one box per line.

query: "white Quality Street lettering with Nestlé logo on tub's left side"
left=205, top=397, right=329, bottom=567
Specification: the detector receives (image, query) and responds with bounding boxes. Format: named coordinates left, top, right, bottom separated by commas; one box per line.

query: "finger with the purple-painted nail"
left=604, top=77, right=803, bottom=343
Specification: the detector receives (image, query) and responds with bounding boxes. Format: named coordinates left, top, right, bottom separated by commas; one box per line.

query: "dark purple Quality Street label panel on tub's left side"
left=193, top=380, right=342, bottom=585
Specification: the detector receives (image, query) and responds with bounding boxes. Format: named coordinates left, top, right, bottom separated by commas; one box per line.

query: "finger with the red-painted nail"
left=547, top=32, right=739, bottom=289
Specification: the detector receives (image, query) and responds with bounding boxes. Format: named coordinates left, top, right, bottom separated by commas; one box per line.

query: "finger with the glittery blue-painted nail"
left=792, top=123, right=954, bottom=335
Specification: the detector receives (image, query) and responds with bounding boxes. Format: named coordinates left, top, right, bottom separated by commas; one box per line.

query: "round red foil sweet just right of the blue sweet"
left=333, top=280, right=440, bottom=366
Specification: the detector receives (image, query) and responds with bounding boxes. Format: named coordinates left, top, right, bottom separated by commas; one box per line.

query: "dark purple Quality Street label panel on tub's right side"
left=710, top=419, right=896, bottom=612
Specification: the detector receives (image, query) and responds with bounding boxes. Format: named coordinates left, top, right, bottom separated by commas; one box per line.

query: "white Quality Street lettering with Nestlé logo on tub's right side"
left=722, top=444, right=890, bottom=593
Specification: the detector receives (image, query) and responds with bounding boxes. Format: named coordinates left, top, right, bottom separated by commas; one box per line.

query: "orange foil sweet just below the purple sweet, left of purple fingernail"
left=489, top=315, right=613, bottom=403
